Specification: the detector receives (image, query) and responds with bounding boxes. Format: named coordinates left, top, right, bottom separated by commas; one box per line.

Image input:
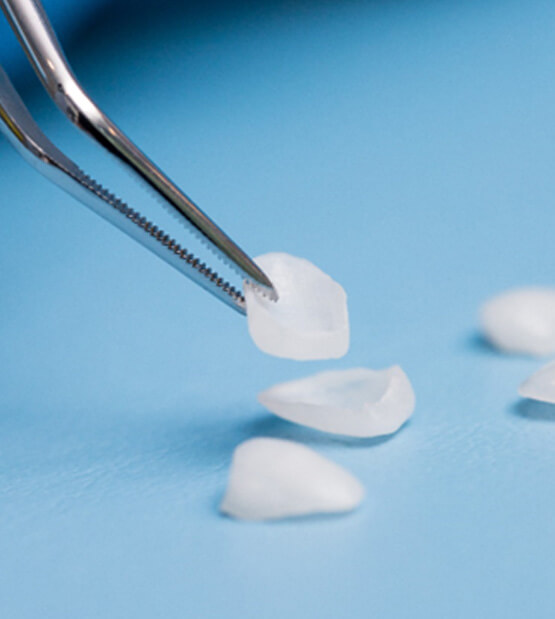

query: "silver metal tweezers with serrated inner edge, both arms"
left=0, top=0, right=277, bottom=314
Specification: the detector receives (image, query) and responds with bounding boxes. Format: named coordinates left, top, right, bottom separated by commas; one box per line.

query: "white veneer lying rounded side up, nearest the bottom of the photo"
left=220, top=438, right=364, bottom=520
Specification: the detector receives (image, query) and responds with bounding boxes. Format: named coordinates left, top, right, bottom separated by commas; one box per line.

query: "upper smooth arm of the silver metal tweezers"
left=0, top=0, right=275, bottom=297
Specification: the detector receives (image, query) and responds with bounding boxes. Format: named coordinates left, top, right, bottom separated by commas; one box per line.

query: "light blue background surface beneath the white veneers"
left=0, top=0, right=555, bottom=619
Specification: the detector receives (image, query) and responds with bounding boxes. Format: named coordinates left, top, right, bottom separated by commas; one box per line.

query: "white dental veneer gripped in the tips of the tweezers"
left=245, top=253, right=349, bottom=361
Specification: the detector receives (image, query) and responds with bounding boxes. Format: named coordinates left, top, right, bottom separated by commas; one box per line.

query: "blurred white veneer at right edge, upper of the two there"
left=481, top=287, right=555, bottom=356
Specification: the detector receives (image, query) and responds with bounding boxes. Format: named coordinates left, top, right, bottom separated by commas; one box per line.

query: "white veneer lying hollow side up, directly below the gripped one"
left=258, top=366, right=415, bottom=437
